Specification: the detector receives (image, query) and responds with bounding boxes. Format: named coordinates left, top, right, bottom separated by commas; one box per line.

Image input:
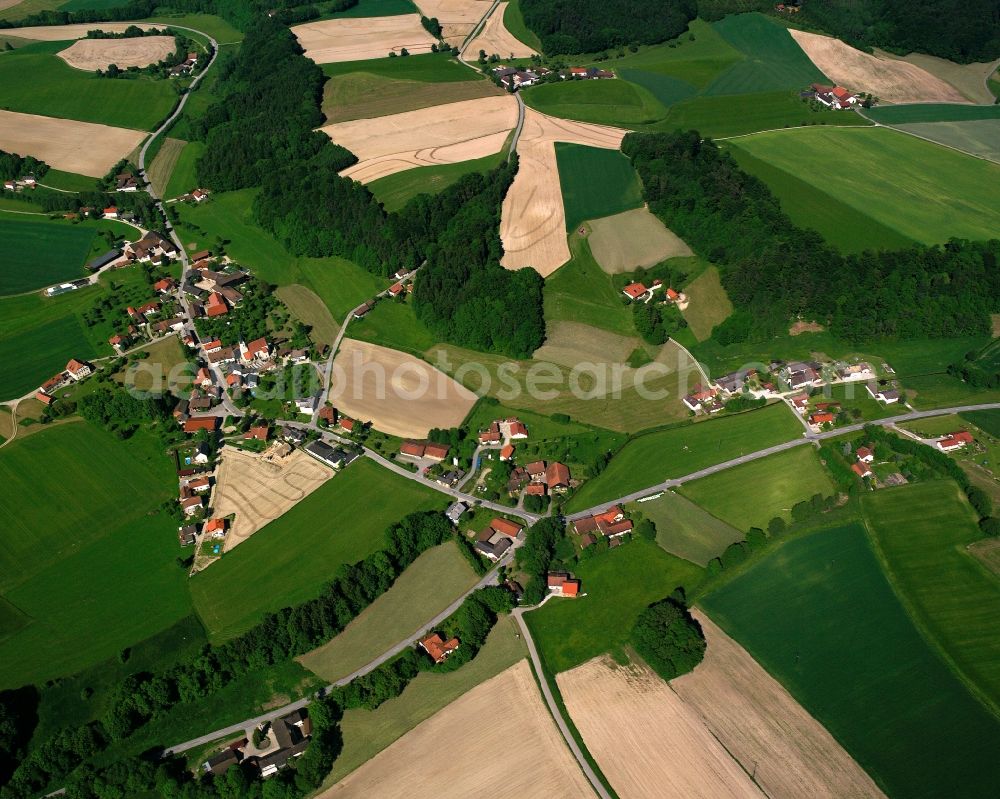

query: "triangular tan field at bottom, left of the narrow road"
left=319, top=660, right=594, bottom=799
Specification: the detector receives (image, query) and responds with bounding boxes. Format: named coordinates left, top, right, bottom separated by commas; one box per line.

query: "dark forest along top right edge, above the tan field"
left=698, top=0, right=1000, bottom=64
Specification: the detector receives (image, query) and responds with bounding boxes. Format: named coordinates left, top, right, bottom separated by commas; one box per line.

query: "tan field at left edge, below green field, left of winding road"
left=0, top=111, right=146, bottom=178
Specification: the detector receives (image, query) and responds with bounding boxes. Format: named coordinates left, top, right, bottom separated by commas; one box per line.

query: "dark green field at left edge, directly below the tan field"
left=0, top=214, right=97, bottom=295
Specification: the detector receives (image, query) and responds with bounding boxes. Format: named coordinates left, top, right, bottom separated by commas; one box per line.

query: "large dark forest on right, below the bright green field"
left=622, top=131, right=1000, bottom=344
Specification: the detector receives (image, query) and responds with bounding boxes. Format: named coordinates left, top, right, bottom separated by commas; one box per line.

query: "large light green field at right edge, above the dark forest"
left=736, top=128, right=1000, bottom=244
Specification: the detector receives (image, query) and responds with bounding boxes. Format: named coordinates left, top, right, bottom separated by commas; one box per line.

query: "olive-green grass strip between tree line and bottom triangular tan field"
left=323, top=617, right=527, bottom=788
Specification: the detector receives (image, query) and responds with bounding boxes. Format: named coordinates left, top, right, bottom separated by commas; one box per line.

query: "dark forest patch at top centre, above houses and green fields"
left=521, top=0, right=697, bottom=55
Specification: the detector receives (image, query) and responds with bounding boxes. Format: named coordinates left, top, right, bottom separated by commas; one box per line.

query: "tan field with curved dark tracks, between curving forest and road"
left=323, top=94, right=520, bottom=183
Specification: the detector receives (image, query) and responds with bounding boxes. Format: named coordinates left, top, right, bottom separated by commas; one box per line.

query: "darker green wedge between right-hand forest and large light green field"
left=727, top=144, right=914, bottom=254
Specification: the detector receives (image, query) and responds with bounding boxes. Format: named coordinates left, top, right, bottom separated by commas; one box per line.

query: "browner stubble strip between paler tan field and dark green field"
left=670, top=611, right=884, bottom=799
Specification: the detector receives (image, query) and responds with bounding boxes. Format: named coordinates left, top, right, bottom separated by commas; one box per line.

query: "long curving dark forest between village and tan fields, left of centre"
left=195, top=17, right=544, bottom=357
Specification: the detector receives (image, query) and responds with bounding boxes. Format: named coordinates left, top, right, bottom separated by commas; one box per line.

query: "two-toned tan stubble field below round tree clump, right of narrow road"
left=557, top=612, right=883, bottom=799
